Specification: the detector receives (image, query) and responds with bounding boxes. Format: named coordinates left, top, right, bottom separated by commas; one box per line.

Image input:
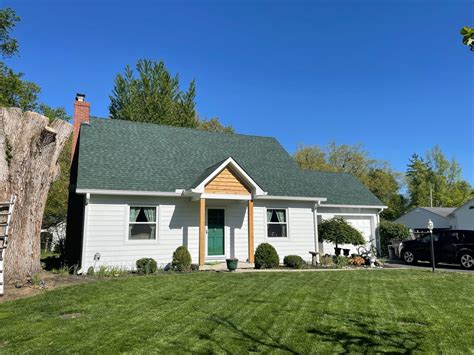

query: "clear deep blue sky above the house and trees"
left=0, top=0, right=474, bottom=184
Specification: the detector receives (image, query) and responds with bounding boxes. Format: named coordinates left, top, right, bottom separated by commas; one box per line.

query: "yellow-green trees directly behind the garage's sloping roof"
left=294, top=142, right=406, bottom=219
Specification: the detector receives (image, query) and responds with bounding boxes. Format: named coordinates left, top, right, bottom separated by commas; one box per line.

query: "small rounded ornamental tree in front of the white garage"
left=318, top=217, right=365, bottom=248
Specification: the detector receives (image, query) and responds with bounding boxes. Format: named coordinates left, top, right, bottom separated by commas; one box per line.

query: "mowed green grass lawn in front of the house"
left=0, top=270, right=474, bottom=353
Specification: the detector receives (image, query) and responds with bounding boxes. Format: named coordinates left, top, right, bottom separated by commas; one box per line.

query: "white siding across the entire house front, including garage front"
left=82, top=195, right=382, bottom=270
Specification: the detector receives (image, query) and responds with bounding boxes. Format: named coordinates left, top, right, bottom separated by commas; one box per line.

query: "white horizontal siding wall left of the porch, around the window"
left=82, top=196, right=199, bottom=269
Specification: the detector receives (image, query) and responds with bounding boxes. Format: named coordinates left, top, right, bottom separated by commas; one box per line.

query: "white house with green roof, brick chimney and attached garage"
left=66, top=96, right=385, bottom=270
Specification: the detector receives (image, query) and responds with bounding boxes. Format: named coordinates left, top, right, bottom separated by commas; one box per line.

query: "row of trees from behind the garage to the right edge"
left=294, top=142, right=474, bottom=220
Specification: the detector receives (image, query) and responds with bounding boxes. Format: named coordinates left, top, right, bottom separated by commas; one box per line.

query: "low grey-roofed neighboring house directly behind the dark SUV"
left=395, top=207, right=455, bottom=232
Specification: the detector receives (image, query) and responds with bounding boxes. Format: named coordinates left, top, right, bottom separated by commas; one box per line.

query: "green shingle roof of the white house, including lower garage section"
left=77, top=118, right=382, bottom=205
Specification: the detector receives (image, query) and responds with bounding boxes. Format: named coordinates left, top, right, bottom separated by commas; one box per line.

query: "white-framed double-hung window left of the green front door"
left=128, top=206, right=156, bottom=240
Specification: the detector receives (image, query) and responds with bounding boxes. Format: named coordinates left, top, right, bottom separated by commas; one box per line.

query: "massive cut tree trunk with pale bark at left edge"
left=0, top=108, right=72, bottom=282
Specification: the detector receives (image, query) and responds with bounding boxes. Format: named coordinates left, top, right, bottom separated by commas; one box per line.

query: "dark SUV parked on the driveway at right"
left=400, top=230, right=474, bottom=269
